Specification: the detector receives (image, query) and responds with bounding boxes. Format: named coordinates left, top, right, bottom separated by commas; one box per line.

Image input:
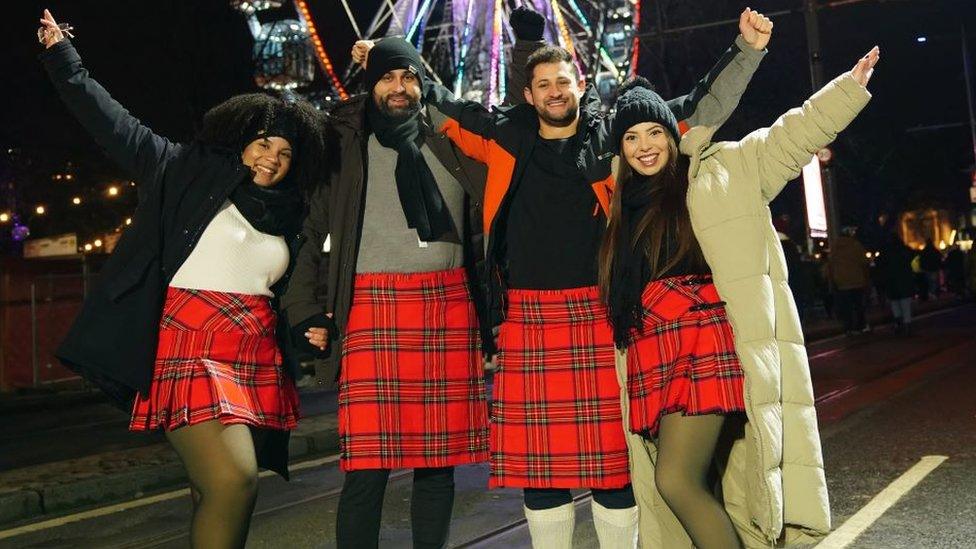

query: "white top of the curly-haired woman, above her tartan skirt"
left=169, top=201, right=288, bottom=297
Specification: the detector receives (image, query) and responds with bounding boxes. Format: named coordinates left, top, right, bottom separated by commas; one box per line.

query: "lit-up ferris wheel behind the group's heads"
left=231, top=0, right=641, bottom=105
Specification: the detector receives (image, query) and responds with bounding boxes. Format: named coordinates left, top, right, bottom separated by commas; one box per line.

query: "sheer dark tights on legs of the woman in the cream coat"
left=654, top=413, right=742, bottom=549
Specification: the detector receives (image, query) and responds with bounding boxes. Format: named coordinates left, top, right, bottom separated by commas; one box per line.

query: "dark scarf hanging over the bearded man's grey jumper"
left=366, top=100, right=453, bottom=241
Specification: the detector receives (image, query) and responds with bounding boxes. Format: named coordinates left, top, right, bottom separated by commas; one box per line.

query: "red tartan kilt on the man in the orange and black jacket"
left=488, top=287, right=630, bottom=488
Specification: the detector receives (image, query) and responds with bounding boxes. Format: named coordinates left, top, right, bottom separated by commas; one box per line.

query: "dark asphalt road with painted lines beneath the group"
left=0, top=305, right=976, bottom=549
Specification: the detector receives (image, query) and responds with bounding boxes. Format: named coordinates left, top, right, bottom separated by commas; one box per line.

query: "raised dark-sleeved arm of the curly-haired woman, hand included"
left=38, top=10, right=180, bottom=201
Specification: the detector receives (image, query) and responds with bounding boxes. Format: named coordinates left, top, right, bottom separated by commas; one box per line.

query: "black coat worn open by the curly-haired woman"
left=40, top=40, right=300, bottom=476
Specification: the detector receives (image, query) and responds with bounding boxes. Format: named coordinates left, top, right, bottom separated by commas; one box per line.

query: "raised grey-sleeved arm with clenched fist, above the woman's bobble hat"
left=668, top=8, right=773, bottom=131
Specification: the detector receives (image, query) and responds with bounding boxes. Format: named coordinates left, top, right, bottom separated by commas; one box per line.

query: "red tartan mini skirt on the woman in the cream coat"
left=627, top=275, right=745, bottom=436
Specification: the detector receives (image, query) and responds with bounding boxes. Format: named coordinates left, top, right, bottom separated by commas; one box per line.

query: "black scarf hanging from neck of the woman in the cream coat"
left=607, top=175, right=653, bottom=349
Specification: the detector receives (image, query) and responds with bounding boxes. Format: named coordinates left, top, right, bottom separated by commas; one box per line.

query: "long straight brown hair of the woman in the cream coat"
left=599, top=135, right=706, bottom=299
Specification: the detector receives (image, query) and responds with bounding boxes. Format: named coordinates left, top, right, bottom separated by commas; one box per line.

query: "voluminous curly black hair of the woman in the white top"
left=197, top=93, right=329, bottom=193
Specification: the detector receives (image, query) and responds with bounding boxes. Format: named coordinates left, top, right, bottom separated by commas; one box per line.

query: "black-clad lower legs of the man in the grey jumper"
left=336, top=467, right=454, bottom=549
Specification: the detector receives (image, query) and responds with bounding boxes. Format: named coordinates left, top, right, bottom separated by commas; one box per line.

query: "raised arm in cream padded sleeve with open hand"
left=738, top=47, right=880, bottom=202
